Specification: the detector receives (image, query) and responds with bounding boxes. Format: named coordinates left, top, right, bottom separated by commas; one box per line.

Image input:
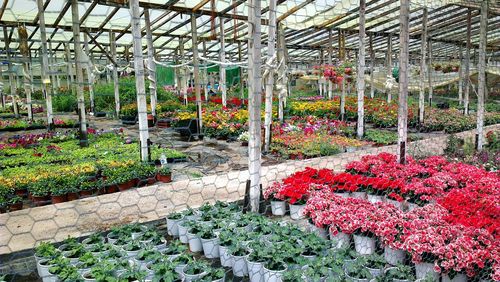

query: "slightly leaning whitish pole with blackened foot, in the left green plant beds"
left=71, top=0, right=89, bottom=147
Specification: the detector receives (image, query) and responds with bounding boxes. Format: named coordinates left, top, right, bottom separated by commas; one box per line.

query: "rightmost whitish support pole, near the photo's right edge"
left=476, top=0, right=488, bottom=151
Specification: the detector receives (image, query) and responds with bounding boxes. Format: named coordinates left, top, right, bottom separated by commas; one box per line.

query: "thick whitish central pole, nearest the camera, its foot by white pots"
left=248, top=0, right=264, bottom=212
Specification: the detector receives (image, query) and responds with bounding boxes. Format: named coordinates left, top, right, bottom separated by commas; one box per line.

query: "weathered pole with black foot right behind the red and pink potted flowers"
left=398, top=0, right=410, bottom=164
